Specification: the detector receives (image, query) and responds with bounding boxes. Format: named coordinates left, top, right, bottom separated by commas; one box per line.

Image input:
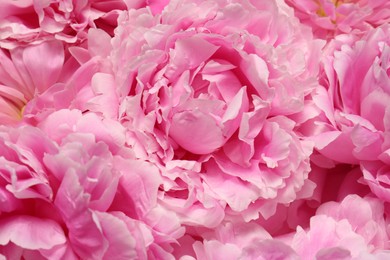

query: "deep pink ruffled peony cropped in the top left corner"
left=0, top=0, right=126, bottom=49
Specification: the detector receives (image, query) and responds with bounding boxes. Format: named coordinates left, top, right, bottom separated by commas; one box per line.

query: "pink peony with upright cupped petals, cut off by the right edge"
left=301, top=25, right=390, bottom=200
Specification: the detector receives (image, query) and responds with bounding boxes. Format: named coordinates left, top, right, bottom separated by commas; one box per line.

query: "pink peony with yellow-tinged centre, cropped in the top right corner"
left=286, top=0, right=390, bottom=39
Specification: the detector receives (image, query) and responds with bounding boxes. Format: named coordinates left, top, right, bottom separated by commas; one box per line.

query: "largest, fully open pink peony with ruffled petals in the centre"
left=111, top=1, right=323, bottom=227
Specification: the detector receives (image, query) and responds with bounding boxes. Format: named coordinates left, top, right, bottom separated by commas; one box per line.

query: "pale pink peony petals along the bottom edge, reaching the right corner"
left=174, top=195, right=389, bottom=260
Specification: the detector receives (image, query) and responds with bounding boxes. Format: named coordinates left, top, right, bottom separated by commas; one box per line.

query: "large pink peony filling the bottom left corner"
left=0, top=110, right=182, bottom=259
